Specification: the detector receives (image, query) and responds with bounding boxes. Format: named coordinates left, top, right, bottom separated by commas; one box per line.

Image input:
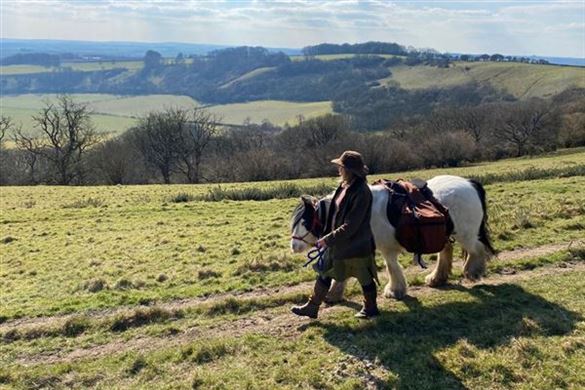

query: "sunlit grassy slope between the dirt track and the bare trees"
left=0, top=152, right=585, bottom=317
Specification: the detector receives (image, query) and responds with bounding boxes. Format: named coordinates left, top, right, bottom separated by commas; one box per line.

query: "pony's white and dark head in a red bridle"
left=290, top=195, right=322, bottom=253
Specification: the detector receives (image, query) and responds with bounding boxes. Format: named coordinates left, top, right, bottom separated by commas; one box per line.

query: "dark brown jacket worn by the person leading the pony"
left=323, top=177, right=375, bottom=259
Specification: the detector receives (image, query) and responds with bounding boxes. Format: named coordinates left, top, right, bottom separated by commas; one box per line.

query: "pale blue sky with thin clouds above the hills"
left=0, top=0, right=585, bottom=58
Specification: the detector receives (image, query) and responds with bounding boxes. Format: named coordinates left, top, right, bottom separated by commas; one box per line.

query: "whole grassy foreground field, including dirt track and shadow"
left=0, top=149, right=585, bottom=389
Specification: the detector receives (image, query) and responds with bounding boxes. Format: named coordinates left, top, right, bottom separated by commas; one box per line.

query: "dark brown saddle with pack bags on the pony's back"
left=373, top=179, right=453, bottom=258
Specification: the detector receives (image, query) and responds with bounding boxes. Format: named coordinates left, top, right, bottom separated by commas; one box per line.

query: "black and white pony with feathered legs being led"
left=291, top=175, right=495, bottom=301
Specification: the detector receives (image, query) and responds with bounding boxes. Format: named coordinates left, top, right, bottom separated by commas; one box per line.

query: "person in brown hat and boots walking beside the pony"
left=291, top=150, right=380, bottom=318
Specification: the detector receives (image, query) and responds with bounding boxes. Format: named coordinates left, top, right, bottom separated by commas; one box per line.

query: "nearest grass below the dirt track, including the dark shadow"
left=0, top=264, right=585, bottom=389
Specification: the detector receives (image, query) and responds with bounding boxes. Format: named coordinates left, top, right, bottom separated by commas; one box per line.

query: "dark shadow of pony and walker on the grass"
left=310, top=284, right=580, bottom=389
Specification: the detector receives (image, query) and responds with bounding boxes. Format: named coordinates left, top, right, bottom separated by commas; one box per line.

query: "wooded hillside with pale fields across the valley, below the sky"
left=0, top=47, right=585, bottom=130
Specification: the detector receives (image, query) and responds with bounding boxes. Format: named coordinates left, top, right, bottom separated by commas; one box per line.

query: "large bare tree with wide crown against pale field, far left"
left=14, top=95, right=100, bottom=185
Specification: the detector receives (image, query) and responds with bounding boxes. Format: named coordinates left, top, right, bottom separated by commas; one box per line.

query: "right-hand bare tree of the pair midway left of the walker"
left=179, top=108, right=220, bottom=183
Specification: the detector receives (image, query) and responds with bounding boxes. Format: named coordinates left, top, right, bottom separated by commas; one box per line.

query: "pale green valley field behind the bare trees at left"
left=1, top=94, right=332, bottom=134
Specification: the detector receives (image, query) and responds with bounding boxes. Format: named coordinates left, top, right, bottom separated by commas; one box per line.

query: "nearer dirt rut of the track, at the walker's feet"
left=15, top=262, right=585, bottom=370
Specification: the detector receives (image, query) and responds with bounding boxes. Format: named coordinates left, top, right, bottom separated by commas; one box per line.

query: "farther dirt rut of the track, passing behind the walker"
left=0, top=242, right=585, bottom=334
